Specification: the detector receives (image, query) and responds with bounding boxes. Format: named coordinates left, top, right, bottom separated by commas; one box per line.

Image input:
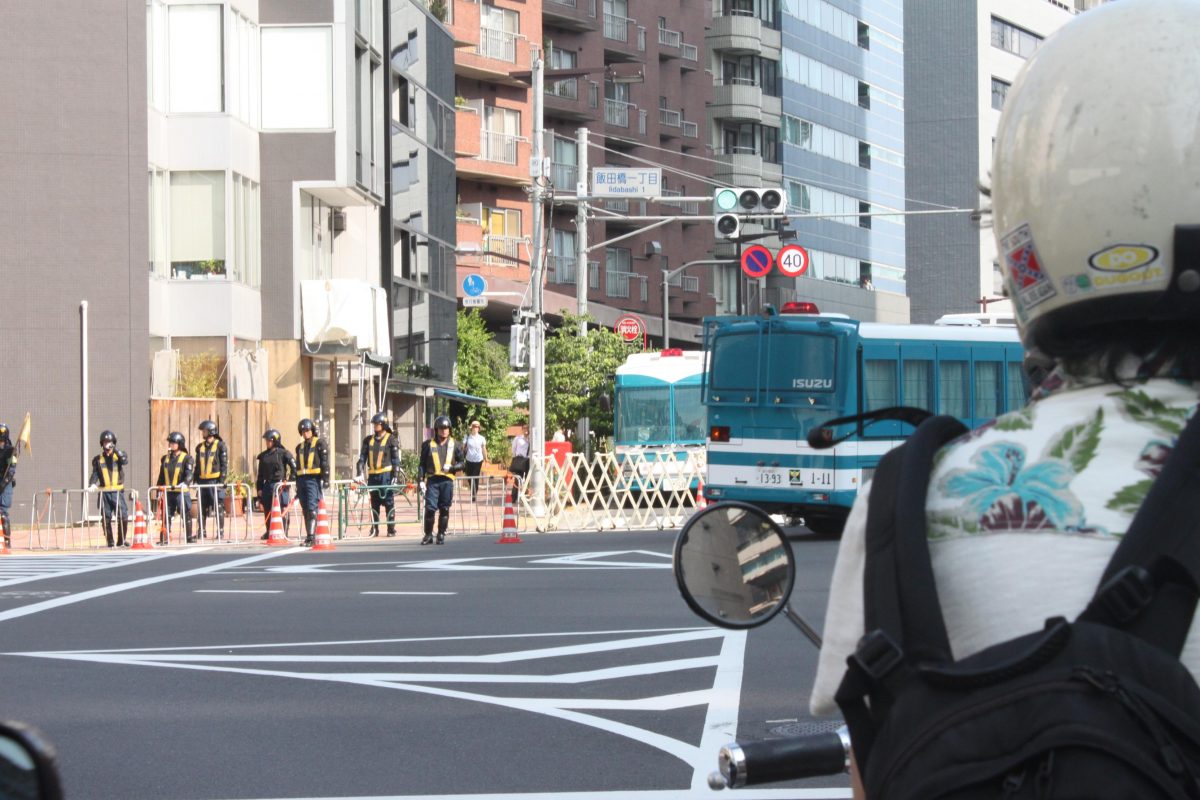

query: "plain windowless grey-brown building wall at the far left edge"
left=0, top=0, right=150, bottom=503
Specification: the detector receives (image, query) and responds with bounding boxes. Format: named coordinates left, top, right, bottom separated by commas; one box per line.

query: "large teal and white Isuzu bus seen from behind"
left=703, top=302, right=1028, bottom=534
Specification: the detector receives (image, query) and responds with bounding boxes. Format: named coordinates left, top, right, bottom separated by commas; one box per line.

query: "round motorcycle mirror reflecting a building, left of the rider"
left=673, top=501, right=796, bottom=628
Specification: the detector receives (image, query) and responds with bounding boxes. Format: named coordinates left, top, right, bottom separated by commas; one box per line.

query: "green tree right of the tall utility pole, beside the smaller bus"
left=546, top=314, right=637, bottom=438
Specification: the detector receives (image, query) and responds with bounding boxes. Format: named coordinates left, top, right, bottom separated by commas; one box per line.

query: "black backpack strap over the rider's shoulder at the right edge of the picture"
left=1079, top=414, right=1200, bottom=656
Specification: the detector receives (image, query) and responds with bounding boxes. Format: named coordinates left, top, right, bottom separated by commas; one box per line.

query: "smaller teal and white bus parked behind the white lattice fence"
left=613, top=349, right=708, bottom=489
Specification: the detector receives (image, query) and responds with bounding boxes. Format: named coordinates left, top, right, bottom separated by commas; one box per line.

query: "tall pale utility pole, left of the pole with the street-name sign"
left=529, top=46, right=546, bottom=517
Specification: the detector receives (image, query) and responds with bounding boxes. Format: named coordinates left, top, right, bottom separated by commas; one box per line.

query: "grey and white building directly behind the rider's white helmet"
left=905, top=0, right=1098, bottom=323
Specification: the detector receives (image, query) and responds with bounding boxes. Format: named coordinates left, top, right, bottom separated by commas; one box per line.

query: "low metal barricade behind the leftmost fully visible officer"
left=26, top=488, right=139, bottom=551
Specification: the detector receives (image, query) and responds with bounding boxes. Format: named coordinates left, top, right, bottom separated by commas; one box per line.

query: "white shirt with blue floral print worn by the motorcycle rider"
left=811, top=372, right=1200, bottom=714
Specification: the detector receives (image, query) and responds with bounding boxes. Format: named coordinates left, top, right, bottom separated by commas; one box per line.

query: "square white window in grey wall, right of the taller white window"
left=262, top=25, right=334, bottom=131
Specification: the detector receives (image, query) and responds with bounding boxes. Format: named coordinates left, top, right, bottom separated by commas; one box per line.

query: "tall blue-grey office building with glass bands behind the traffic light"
left=708, top=0, right=908, bottom=321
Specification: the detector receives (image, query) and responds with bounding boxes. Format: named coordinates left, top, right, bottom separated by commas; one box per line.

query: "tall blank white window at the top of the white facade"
left=167, top=5, right=224, bottom=114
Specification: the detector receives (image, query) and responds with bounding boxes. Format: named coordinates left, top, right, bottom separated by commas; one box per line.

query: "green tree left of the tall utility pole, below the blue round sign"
left=455, top=308, right=516, bottom=461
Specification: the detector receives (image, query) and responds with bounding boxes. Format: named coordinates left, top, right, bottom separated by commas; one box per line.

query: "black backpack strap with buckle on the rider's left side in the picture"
left=835, top=416, right=967, bottom=769
